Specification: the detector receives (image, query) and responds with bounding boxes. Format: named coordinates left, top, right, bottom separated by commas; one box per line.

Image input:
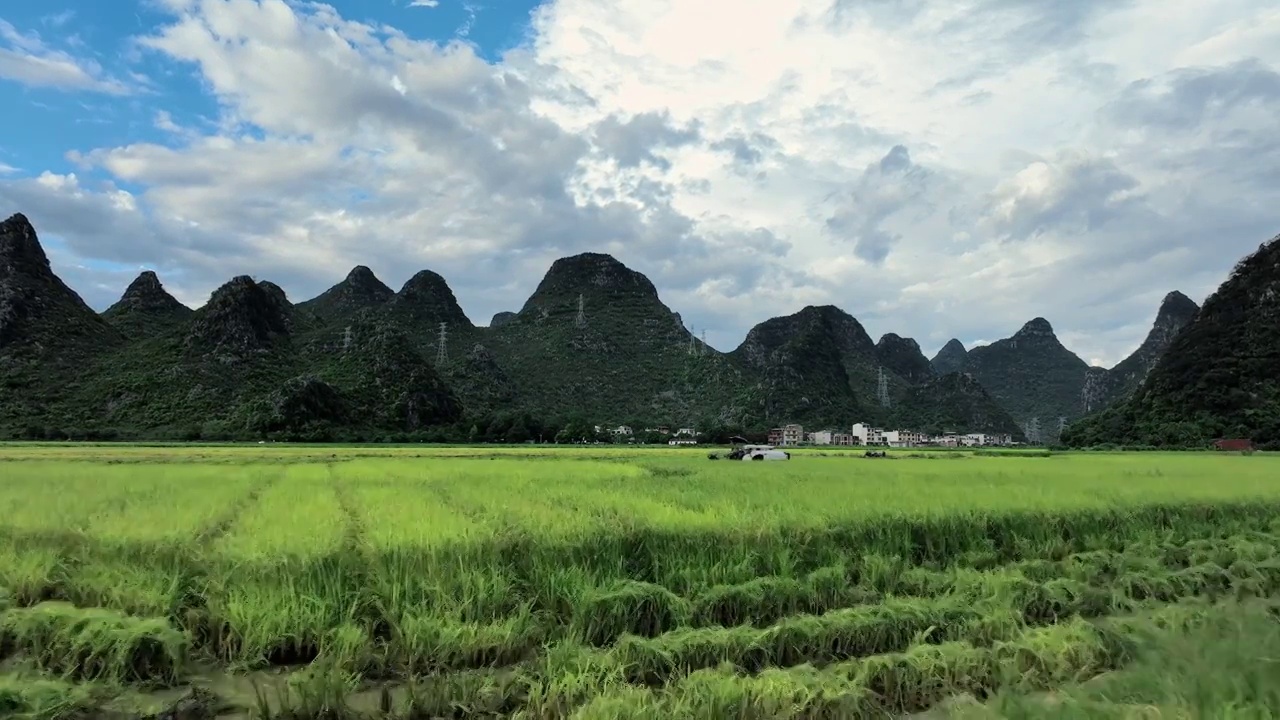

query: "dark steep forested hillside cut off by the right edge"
left=1062, top=237, right=1280, bottom=447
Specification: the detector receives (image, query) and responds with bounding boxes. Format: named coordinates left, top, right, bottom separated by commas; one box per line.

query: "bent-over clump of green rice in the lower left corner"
left=0, top=602, right=187, bottom=685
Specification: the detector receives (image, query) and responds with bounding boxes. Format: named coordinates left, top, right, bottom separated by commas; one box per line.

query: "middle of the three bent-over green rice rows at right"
left=611, top=545, right=1280, bottom=684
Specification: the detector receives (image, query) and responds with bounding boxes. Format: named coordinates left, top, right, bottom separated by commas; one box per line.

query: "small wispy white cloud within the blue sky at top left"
left=0, top=18, right=132, bottom=95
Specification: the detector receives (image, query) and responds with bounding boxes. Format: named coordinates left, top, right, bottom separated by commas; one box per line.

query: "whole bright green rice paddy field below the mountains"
left=0, top=445, right=1280, bottom=720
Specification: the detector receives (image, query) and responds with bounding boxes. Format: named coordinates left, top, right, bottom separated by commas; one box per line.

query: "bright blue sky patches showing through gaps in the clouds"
left=0, top=0, right=538, bottom=179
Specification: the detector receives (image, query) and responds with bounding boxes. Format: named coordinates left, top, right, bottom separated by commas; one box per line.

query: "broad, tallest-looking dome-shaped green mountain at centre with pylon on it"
left=483, top=252, right=762, bottom=425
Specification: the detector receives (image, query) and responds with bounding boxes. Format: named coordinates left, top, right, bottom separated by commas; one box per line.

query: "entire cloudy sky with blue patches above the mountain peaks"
left=0, top=0, right=1280, bottom=366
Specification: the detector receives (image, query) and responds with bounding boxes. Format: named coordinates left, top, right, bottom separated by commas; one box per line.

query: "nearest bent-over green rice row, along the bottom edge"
left=235, top=602, right=1264, bottom=720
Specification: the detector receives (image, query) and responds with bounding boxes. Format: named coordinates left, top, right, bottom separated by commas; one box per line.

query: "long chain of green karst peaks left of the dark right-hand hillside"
left=0, top=210, right=1249, bottom=438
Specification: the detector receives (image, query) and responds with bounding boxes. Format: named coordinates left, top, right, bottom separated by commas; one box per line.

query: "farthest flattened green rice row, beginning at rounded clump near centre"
left=570, top=527, right=1280, bottom=646
